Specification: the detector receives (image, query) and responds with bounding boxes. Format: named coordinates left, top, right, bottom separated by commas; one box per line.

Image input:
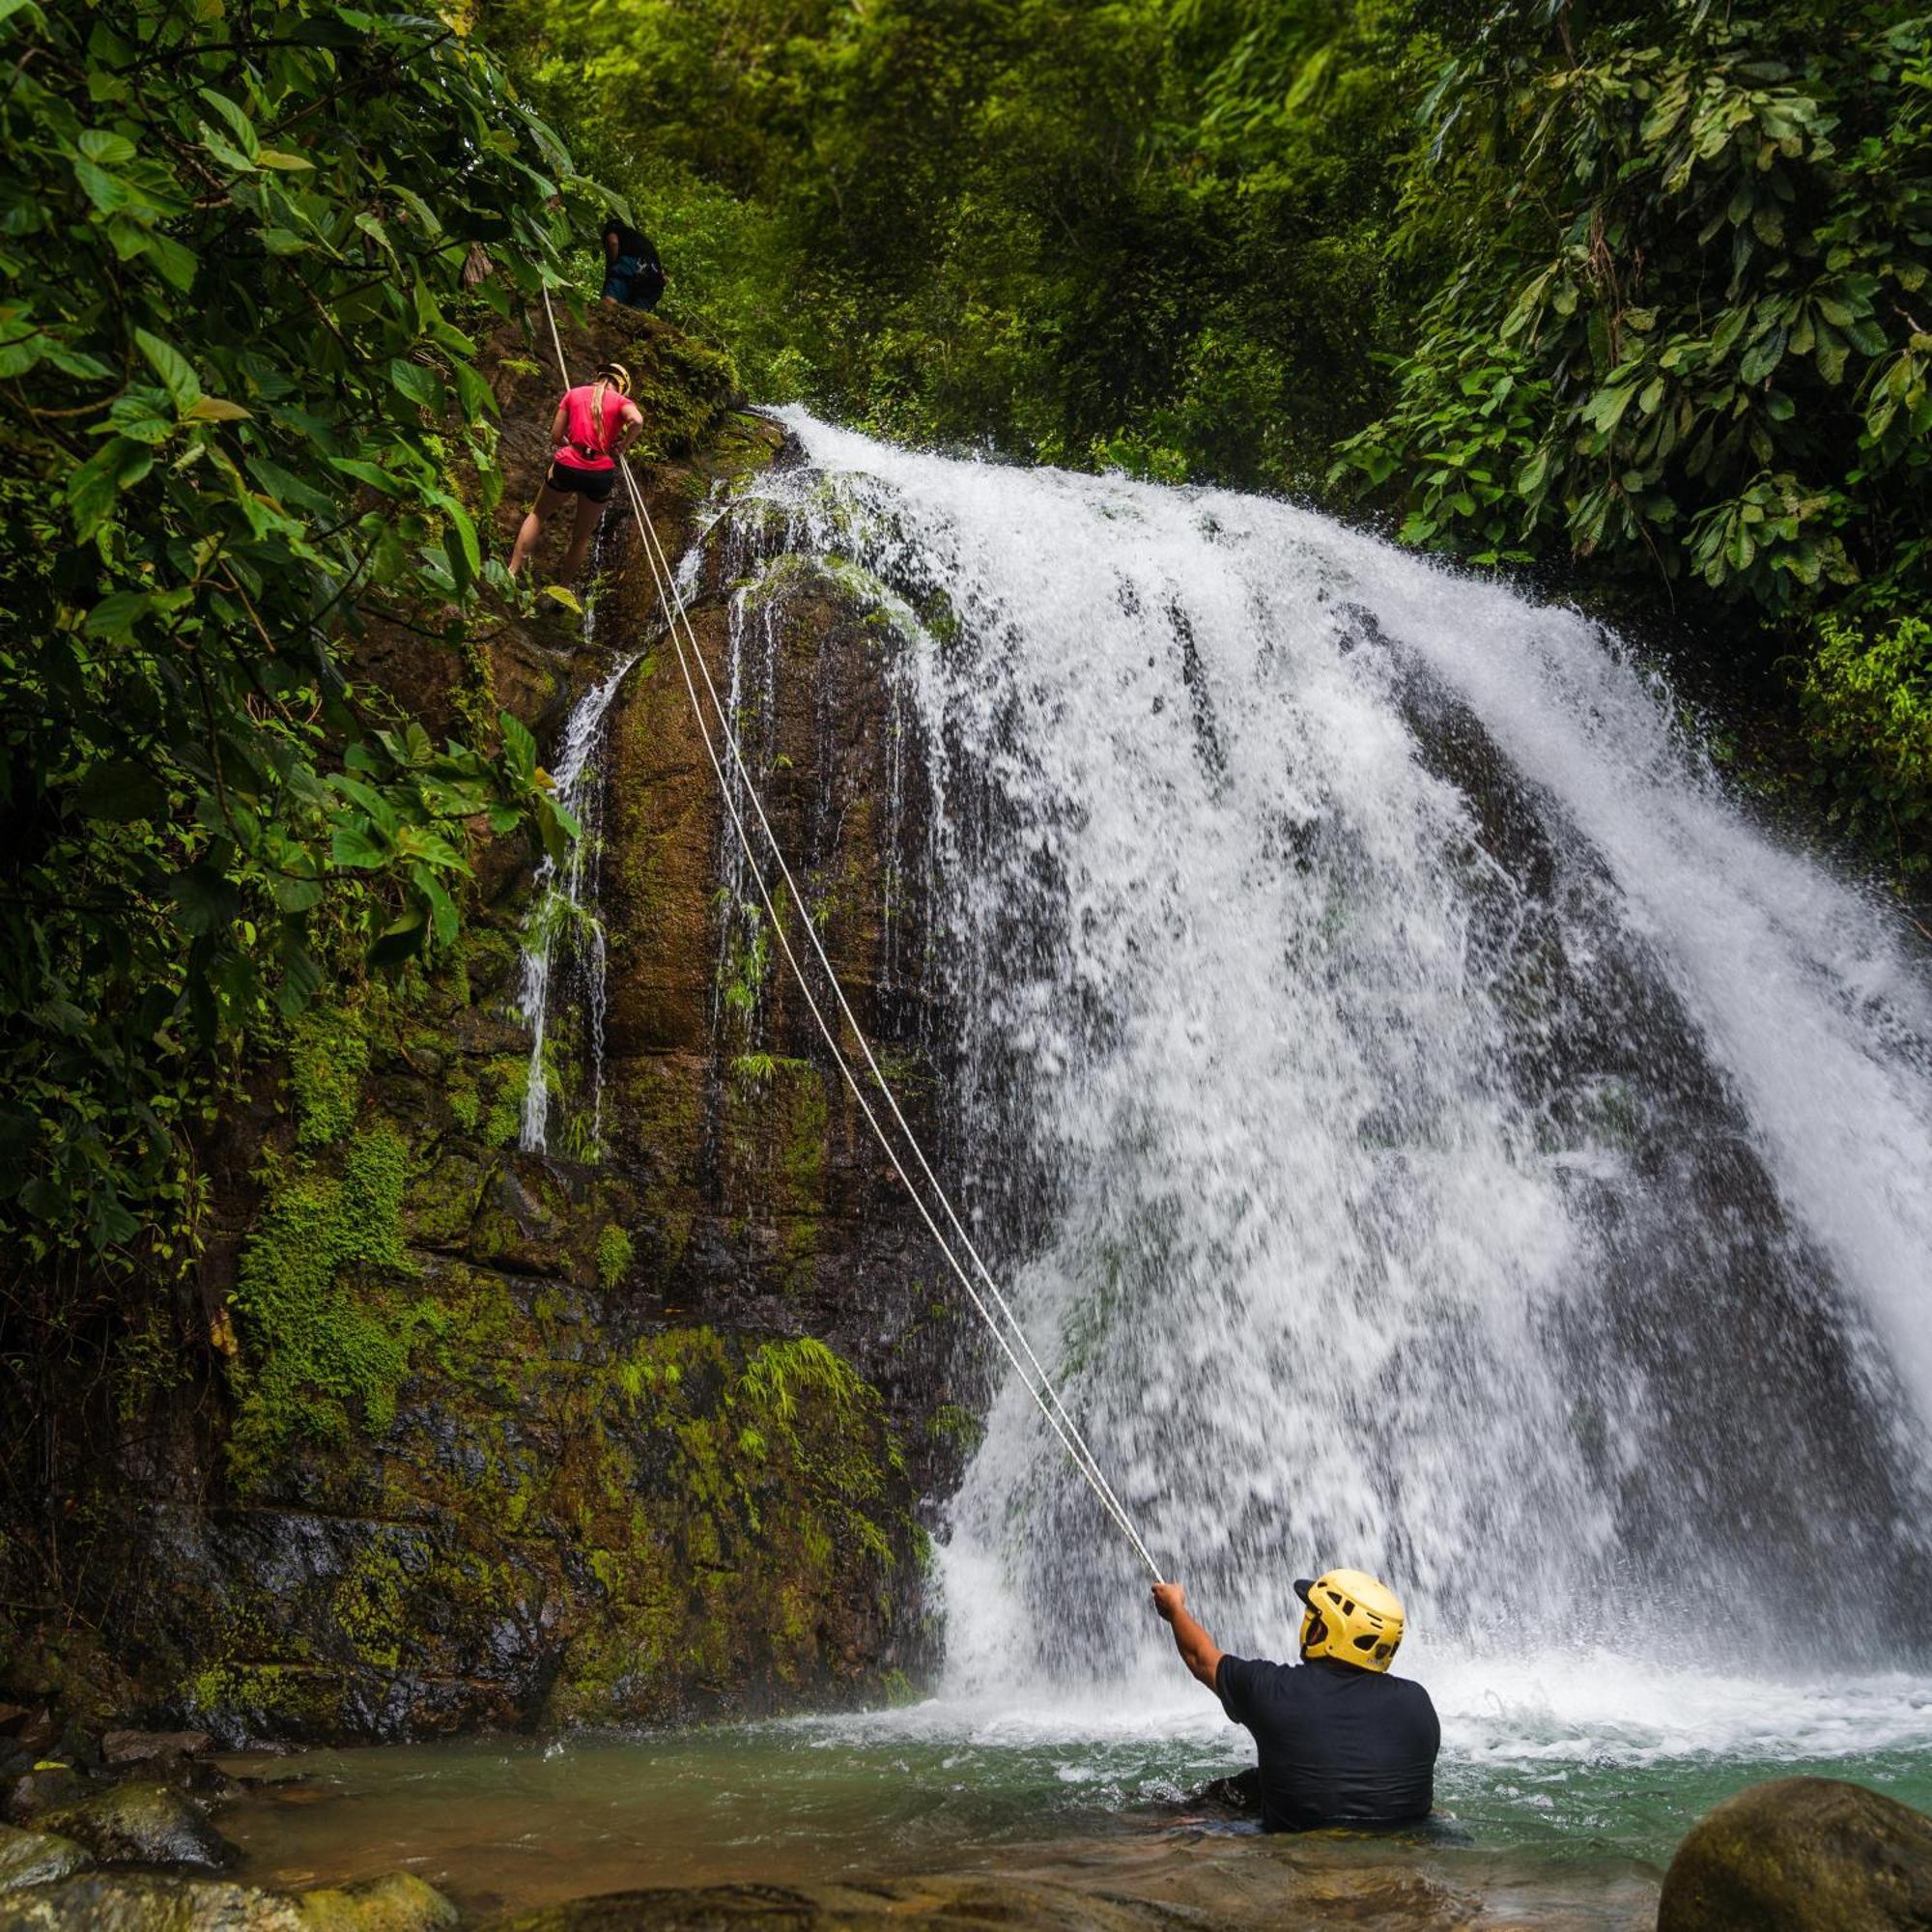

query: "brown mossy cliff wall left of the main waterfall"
left=6, top=313, right=964, bottom=1739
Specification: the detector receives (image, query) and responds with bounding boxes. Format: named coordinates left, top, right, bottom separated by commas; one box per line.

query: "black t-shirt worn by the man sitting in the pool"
left=1213, top=1656, right=1441, bottom=1832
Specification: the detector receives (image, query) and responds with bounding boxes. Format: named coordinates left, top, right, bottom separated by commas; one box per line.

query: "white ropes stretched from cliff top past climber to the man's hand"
left=543, top=288, right=1161, bottom=1582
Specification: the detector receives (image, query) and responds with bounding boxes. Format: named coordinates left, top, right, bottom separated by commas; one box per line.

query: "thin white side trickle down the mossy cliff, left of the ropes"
left=518, top=626, right=638, bottom=1153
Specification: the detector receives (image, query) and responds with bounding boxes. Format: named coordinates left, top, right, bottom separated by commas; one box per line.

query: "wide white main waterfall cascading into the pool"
left=736, top=412, right=1932, bottom=1681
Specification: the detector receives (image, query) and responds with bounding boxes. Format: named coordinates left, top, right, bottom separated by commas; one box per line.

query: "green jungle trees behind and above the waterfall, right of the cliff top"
left=502, top=0, right=1932, bottom=871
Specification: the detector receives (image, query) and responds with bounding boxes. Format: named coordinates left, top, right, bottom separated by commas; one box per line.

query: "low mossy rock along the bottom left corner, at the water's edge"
left=0, top=1872, right=458, bottom=1932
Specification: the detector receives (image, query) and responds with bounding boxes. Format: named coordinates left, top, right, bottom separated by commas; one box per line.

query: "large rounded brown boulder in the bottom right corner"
left=1658, top=1777, right=1932, bottom=1932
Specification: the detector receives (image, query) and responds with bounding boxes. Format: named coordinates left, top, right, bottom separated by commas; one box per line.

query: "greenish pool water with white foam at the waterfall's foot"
left=224, top=1658, right=1932, bottom=1926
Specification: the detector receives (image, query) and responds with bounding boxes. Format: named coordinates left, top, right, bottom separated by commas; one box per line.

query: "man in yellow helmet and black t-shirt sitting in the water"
left=1153, top=1571, right=1441, bottom=1832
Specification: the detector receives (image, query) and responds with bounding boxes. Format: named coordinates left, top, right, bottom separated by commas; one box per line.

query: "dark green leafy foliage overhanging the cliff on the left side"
left=0, top=0, right=574, bottom=1279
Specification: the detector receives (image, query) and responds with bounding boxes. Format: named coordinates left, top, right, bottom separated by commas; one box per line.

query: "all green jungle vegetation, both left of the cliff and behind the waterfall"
left=0, top=0, right=1932, bottom=1306
